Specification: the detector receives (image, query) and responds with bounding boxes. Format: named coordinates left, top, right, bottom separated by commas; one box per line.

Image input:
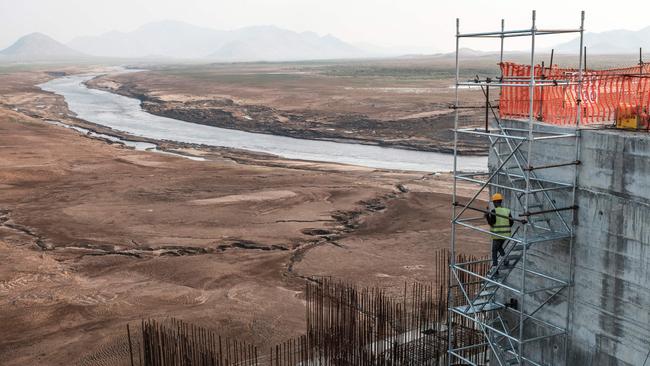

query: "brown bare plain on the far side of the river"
left=88, top=60, right=487, bottom=154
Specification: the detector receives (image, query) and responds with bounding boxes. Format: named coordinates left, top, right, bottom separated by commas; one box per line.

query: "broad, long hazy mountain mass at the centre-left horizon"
left=68, top=21, right=372, bottom=61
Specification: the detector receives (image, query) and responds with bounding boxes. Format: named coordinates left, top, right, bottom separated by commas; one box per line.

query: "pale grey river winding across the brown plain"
left=39, top=74, right=487, bottom=172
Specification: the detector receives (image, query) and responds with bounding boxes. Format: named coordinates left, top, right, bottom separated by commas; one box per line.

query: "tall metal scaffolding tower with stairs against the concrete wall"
left=448, top=11, right=584, bottom=366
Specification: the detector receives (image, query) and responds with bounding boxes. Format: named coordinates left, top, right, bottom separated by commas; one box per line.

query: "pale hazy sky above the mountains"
left=0, top=0, right=650, bottom=52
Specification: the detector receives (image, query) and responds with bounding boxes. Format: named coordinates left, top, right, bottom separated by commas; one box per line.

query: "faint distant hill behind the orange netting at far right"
left=555, top=27, right=650, bottom=55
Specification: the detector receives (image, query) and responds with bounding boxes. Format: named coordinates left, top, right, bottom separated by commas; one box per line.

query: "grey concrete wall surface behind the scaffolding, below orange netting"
left=489, top=121, right=650, bottom=366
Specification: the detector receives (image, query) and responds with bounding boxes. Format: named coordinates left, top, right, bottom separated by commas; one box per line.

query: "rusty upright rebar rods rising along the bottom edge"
left=127, top=250, right=489, bottom=366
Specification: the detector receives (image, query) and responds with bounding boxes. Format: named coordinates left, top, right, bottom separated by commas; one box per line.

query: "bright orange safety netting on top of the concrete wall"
left=499, top=62, right=650, bottom=125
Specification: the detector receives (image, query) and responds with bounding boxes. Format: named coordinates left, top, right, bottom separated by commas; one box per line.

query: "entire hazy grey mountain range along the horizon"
left=0, top=20, right=650, bottom=62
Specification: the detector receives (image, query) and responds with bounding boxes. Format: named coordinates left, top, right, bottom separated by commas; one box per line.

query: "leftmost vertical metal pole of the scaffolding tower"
left=447, top=18, right=460, bottom=366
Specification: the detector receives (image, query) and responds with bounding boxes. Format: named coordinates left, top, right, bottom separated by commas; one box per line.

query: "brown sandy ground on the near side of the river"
left=0, top=68, right=488, bottom=365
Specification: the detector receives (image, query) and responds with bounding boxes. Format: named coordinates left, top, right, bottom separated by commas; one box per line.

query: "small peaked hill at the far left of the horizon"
left=0, top=33, right=87, bottom=62
